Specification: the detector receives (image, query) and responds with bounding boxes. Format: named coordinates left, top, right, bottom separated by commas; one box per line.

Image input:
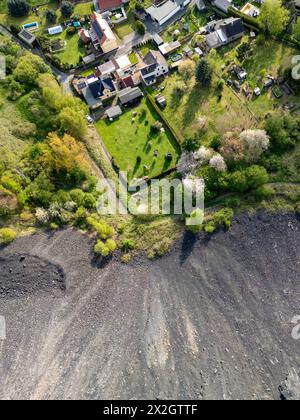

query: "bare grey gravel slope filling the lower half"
left=0, top=214, right=300, bottom=399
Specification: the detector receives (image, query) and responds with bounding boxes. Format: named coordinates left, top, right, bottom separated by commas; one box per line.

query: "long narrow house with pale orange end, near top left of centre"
left=90, top=12, right=119, bottom=54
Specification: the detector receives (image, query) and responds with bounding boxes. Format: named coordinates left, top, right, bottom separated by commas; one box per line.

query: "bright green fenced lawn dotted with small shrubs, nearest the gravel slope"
left=96, top=99, right=179, bottom=179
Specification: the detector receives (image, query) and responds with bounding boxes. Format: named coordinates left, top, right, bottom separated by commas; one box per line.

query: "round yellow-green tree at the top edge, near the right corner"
left=259, top=0, right=289, bottom=35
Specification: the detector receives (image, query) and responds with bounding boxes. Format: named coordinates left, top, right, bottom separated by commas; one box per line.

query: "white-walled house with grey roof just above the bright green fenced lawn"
left=141, top=50, right=169, bottom=86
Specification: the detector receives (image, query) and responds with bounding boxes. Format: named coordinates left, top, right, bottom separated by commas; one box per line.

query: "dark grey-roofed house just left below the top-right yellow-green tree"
left=205, top=17, right=245, bottom=49
